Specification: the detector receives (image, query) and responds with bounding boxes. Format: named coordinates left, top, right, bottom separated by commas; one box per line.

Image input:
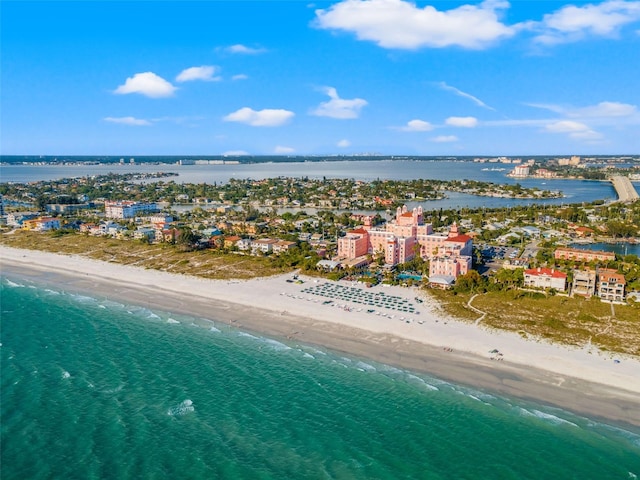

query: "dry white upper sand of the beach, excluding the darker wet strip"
left=0, top=246, right=640, bottom=399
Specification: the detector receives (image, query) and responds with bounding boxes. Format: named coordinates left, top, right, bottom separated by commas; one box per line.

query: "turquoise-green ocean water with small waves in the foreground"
left=0, top=278, right=640, bottom=480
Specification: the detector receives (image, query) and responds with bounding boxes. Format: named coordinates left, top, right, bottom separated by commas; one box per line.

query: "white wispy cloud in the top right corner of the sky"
left=531, top=0, right=640, bottom=45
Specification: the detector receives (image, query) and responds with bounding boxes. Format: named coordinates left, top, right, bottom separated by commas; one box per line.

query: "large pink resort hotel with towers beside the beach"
left=338, top=205, right=473, bottom=287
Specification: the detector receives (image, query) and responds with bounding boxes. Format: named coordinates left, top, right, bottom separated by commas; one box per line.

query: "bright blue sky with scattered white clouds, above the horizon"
left=0, top=0, right=640, bottom=156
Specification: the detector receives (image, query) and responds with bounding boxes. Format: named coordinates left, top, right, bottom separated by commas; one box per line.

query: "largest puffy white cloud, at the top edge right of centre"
left=315, top=0, right=518, bottom=50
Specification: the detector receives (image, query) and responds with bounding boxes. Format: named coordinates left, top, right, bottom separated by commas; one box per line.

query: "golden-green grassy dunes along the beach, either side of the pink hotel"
left=5, top=231, right=640, bottom=356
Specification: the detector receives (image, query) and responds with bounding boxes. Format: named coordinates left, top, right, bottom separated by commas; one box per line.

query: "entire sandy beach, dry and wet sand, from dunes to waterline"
left=0, top=247, right=640, bottom=426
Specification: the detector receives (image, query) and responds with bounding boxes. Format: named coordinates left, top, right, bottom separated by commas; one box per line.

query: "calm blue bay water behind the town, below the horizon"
left=0, top=159, right=624, bottom=210
